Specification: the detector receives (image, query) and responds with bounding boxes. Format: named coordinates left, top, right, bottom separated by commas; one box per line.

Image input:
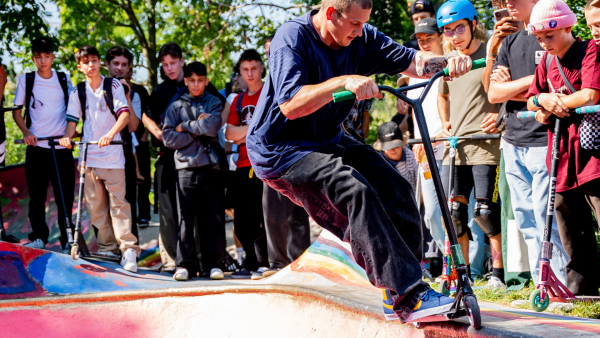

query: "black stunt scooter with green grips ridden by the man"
left=333, top=59, right=485, bottom=329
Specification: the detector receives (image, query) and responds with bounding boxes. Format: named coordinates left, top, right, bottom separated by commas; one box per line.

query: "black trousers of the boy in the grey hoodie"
left=175, top=166, right=225, bottom=277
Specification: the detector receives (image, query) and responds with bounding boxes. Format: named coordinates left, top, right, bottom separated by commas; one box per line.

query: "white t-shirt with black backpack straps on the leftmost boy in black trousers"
left=14, top=71, right=73, bottom=149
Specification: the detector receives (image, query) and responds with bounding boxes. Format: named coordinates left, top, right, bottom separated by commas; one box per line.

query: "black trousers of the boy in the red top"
left=228, top=167, right=269, bottom=271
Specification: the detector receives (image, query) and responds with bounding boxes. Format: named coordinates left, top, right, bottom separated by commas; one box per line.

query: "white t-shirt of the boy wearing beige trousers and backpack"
left=67, top=77, right=129, bottom=169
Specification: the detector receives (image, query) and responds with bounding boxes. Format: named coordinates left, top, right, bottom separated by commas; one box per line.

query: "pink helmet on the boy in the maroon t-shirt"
left=529, top=0, right=577, bottom=34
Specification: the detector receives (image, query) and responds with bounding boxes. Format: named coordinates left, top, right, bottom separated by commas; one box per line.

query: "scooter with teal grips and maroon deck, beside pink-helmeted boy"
left=517, top=105, right=600, bottom=312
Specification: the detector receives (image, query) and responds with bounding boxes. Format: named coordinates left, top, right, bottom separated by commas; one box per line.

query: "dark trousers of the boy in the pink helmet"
left=554, top=178, right=600, bottom=296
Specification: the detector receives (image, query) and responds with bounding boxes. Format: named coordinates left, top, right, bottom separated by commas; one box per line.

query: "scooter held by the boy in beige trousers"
left=48, top=141, right=125, bottom=262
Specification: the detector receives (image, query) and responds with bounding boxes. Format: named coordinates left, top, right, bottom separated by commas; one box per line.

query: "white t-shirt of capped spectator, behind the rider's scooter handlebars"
left=407, top=77, right=444, bottom=161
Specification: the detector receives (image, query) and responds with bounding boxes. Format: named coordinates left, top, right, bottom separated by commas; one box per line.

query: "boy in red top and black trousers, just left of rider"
left=225, top=49, right=269, bottom=279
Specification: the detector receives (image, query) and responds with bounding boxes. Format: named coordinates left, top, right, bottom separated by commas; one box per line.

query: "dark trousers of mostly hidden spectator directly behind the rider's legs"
left=262, top=184, right=310, bottom=269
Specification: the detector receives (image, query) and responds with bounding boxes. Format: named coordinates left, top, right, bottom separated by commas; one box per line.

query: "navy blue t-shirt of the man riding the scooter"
left=246, top=10, right=416, bottom=179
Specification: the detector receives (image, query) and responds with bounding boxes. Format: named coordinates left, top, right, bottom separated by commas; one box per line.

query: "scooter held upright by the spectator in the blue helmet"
left=408, top=133, right=502, bottom=296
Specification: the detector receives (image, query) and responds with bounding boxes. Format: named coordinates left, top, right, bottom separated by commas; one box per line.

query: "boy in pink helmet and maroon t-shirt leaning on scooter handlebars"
left=526, top=0, right=600, bottom=296
